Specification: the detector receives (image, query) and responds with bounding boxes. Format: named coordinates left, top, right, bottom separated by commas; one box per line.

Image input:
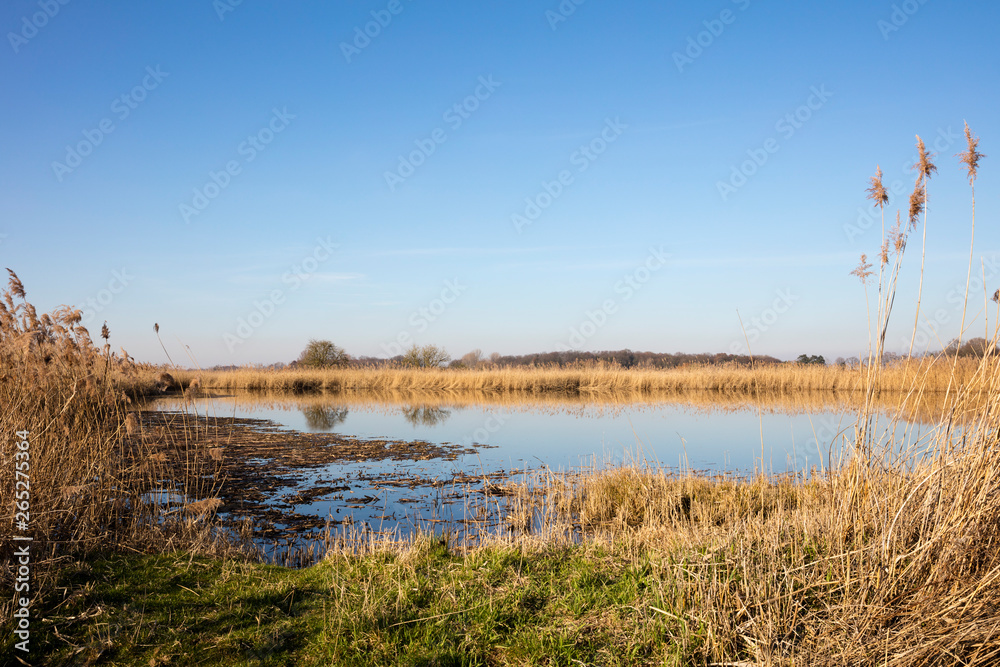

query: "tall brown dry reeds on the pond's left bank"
left=0, top=272, right=249, bottom=611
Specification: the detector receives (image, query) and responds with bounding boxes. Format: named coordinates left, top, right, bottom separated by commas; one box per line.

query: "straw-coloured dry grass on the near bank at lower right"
left=486, top=350, right=1000, bottom=666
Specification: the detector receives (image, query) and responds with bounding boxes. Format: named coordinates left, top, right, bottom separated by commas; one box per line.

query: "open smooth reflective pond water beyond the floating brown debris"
left=156, top=395, right=868, bottom=473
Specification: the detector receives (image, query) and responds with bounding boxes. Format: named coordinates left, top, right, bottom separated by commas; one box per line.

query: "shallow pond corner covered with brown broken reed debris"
left=137, top=410, right=522, bottom=543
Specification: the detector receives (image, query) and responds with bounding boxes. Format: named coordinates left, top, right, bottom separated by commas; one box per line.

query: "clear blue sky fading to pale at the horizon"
left=0, top=0, right=1000, bottom=365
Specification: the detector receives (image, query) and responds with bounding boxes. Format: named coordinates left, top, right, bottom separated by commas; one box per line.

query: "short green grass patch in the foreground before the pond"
left=19, top=540, right=707, bottom=667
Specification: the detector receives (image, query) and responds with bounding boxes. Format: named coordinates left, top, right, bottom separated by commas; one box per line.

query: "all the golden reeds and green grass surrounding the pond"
left=0, top=124, right=1000, bottom=667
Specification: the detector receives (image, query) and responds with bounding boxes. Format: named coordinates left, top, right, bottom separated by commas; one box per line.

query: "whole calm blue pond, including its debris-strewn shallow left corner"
left=146, top=393, right=924, bottom=560
